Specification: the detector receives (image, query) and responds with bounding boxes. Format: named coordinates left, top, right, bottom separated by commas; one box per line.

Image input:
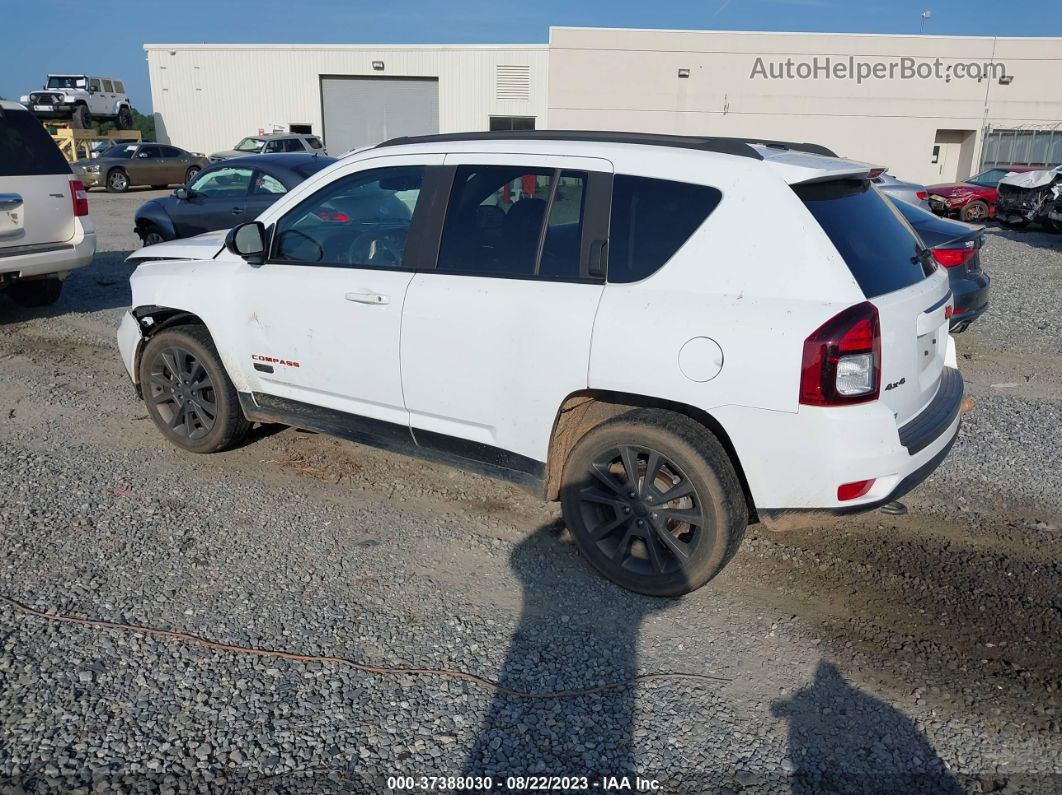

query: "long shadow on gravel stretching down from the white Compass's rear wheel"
left=464, top=522, right=675, bottom=792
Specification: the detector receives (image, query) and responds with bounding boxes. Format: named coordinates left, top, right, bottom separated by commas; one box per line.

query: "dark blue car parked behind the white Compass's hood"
left=136, top=154, right=336, bottom=245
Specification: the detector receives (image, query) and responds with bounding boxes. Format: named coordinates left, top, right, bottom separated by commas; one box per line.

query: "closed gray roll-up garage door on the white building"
left=321, top=75, right=439, bottom=157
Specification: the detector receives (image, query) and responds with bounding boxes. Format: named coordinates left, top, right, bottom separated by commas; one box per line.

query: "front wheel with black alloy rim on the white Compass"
left=139, top=326, right=251, bottom=453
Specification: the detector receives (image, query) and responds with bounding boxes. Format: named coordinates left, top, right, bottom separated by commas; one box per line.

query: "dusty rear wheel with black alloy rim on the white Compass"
left=561, top=409, right=749, bottom=597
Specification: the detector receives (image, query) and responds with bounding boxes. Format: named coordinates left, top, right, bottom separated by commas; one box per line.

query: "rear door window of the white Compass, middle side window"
left=438, top=166, right=587, bottom=279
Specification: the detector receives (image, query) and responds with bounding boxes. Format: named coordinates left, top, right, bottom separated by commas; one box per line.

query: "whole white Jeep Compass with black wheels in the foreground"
left=118, top=132, right=963, bottom=594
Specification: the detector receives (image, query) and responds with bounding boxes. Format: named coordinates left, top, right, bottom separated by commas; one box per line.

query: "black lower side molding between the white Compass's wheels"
left=239, top=392, right=546, bottom=497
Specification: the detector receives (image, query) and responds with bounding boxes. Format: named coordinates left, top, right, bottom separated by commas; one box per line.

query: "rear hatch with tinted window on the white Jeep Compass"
left=793, top=177, right=954, bottom=426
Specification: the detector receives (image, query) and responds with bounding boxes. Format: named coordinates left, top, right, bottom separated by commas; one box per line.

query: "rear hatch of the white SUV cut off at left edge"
left=0, top=103, right=74, bottom=253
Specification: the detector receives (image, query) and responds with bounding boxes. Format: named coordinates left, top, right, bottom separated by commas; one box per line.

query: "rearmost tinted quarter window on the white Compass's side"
left=609, top=174, right=722, bottom=283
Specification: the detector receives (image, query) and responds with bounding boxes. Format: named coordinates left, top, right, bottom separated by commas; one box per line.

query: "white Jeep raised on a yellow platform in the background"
left=19, top=74, right=133, bottom=129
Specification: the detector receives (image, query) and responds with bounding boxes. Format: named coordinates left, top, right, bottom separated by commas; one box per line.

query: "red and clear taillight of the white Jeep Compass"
left=800, top=301, right=881, bottom=405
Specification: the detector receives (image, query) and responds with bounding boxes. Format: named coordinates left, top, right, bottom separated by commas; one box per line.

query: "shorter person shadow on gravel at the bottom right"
left=771, top=660, right=965, bottom=795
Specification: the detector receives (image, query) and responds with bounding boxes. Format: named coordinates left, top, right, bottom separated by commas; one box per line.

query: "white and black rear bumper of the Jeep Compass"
left=713, top=360, right=963, bottom=517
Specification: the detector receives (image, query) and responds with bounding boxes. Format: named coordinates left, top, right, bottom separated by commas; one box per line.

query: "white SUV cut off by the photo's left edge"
left=0, top=101, right=96, bottom=307
